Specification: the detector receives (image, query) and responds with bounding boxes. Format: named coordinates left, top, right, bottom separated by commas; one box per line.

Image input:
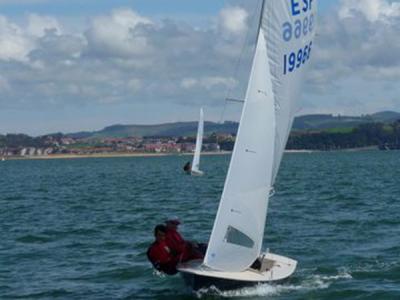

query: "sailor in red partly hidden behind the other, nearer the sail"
left=165, top=217, right=206, bottom=262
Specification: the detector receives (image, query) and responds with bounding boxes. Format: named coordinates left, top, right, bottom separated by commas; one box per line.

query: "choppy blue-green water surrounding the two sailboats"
left=0, top=152, right=400, bottom=299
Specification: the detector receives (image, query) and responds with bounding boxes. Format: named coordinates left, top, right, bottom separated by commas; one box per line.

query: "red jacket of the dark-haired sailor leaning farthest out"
left=147, top=241, right=179, bottom=275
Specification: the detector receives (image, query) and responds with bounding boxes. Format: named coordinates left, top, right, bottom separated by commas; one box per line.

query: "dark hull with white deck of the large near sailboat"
left=178, top=253, right=297, bottom=290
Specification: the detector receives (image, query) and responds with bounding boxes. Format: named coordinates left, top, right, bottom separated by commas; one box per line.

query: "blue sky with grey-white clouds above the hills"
left=0, top=0, right=400, bottom=136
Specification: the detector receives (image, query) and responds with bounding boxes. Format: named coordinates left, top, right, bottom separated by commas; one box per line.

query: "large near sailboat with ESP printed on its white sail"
left=178, top=0, right=317, bottom=290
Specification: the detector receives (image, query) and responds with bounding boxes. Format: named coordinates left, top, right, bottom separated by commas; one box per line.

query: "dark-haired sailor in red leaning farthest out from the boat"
left=147, top=225, right=180, bottom=275
